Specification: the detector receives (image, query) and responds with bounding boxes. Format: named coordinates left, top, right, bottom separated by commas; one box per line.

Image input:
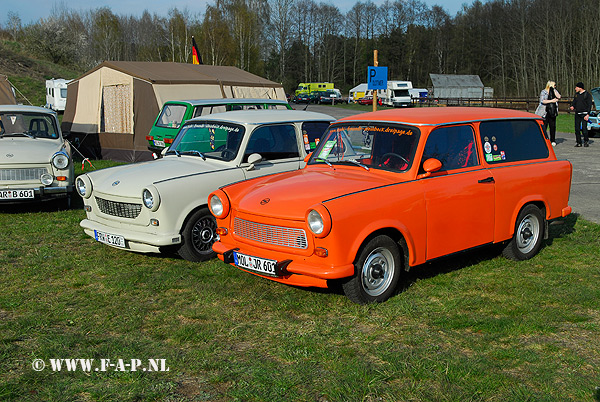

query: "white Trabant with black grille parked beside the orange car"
left=75, top=110, right=335, bottom=261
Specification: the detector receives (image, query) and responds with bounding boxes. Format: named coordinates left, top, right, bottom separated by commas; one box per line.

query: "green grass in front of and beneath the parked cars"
left=0, top=161, right=600, bottom=401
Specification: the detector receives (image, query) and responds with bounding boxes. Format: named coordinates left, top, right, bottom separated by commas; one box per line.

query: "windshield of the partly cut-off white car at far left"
left=0, top=112, right=59, bottom=139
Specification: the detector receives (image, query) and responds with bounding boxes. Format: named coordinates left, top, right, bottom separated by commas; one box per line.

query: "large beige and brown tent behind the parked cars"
left=62, top=61, right=285, bottom=162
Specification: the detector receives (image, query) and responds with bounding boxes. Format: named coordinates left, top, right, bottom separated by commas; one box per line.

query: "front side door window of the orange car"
left=422, top=125, right=479, bottom=171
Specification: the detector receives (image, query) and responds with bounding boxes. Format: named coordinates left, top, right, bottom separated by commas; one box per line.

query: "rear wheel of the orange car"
left=502, top=204, right=546, bottom=261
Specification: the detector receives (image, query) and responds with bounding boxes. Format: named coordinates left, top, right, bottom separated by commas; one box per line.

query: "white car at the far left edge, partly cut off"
left=0, top=105, right=74, bottom=206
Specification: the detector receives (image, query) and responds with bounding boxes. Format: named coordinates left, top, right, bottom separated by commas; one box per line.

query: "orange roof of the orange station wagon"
left=338, top=107, right=541, bottom=126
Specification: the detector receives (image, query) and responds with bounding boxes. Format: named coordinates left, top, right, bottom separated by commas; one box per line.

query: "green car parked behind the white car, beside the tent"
left=146, top=98, right=292, bottom=157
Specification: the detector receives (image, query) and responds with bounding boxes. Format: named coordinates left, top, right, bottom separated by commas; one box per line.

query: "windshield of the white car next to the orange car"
left=167, top=122, right=245, bottom=161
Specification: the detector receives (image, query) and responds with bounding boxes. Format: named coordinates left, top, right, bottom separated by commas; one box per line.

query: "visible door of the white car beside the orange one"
left=242, top=123, right=302, bottom=179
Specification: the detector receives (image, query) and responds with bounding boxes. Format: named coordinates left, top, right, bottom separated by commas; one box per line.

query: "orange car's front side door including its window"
left=421, top=125, right=495, bottom=260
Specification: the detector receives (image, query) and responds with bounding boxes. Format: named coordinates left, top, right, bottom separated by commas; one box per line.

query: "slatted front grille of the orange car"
left=233, top=218, right=308, bottom=250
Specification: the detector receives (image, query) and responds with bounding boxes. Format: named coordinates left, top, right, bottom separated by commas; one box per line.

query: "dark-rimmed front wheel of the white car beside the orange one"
left=177, top=207, right=217, bottom=262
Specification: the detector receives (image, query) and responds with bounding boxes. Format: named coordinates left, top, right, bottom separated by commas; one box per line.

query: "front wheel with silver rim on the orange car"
left=342, top=235, right=402, bottom=304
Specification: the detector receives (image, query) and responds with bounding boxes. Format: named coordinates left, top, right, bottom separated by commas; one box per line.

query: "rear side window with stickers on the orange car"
left=479, top=120, right=549, bottom=164
